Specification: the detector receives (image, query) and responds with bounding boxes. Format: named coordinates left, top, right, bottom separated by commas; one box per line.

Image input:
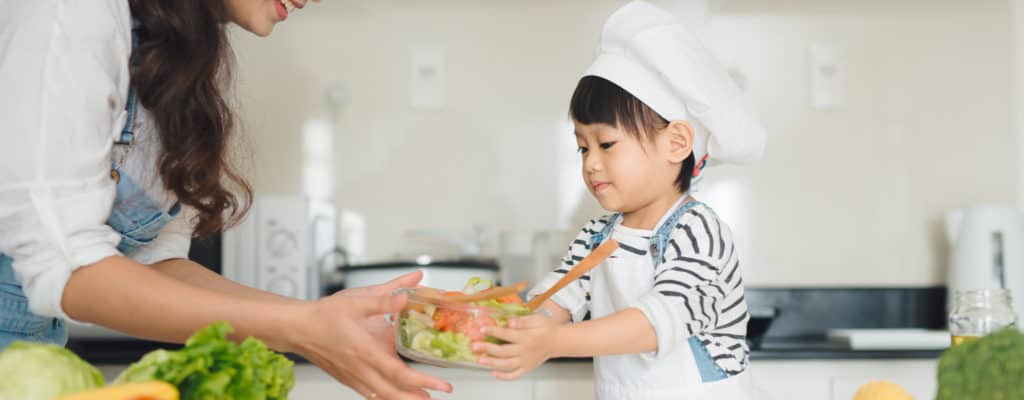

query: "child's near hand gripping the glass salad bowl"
left=473, top=315, right=562, bottom=381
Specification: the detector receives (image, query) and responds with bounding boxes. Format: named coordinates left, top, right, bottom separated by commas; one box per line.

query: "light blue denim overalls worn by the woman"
left=0, top=30, right=181, bottom=350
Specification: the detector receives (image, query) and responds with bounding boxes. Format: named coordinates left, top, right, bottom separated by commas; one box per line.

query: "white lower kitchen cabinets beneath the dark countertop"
left=100, top=359, right=938, bottom=400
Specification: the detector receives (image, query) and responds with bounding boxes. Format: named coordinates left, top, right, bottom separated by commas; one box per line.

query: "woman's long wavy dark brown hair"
left=129, top=0, right=252, bottom=236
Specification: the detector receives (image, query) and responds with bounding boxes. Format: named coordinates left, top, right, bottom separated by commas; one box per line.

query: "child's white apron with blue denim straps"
left=589, top=195, right=754, bottom=400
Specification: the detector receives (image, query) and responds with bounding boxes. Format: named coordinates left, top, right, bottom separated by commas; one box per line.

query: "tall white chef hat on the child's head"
left=584, top=0, right=765, bottom=178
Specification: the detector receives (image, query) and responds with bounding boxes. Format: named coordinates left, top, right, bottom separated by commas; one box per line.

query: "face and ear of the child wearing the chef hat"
left=573, top=121, right=680, bottom=214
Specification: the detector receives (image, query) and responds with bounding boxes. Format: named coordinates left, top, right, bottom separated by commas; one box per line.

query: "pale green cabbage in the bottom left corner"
left=0, top=342, right=103, bottom=400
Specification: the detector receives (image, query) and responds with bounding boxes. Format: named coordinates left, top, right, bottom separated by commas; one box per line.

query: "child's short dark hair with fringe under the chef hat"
left=569, top=76, right=694, bottom=193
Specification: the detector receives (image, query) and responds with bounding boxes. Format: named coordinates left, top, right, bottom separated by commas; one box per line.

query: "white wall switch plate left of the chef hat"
left=412, top=47, right=447, bottom=109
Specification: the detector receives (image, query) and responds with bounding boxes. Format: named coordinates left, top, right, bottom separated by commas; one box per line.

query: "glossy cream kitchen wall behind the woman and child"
left=228, top=0, right=1024, bottom=285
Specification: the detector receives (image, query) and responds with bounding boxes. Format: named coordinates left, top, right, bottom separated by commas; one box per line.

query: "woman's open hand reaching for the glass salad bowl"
left=292, top=272, right=452, bottom=400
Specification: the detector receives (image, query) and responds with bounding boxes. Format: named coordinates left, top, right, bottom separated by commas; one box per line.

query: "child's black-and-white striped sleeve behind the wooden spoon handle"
left=526, top=216, right=610, bottom=322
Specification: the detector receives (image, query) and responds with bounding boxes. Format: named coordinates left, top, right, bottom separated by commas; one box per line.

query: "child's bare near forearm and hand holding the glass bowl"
left=473, top=303, right=657, bottom=380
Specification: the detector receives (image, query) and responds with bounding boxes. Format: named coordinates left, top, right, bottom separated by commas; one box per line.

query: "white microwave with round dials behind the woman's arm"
left=222, top=195, right=337, bottom=300
